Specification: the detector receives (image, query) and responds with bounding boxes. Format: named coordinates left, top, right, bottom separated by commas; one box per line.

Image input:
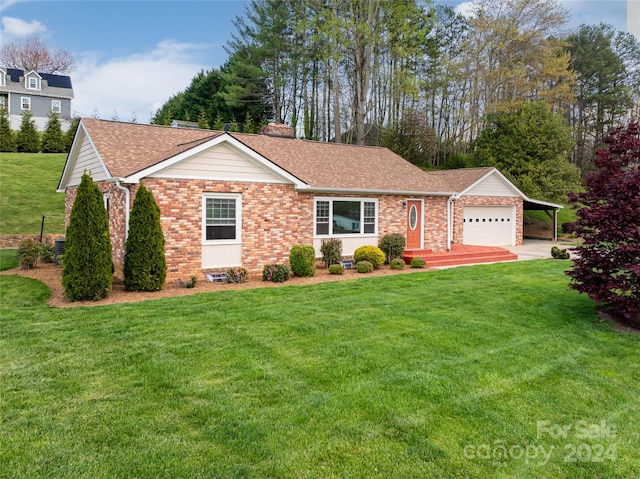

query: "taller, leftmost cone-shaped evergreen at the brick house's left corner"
left=62, top=173, right=113, bottom=301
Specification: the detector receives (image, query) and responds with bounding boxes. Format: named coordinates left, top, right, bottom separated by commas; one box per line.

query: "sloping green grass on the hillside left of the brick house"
left=0, top=153, right=67, bottom=234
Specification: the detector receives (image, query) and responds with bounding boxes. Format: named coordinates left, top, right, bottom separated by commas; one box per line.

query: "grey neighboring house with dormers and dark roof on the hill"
left=0, top=68, right=73, bottom=131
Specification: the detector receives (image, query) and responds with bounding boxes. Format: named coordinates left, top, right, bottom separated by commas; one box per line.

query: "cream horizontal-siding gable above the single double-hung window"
left=149, top=144, right=285, bottom=183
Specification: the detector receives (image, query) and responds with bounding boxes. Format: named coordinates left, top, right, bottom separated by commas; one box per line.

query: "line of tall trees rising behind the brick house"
left=153, top=0, right=640, bottom=195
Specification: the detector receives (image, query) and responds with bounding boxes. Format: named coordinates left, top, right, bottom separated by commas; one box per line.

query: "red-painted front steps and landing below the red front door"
left=402, top=244, right=518, bottom=268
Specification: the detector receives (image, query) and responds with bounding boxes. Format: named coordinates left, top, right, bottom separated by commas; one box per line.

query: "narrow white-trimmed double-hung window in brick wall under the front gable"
left=203, top=193, right=242, bottom=243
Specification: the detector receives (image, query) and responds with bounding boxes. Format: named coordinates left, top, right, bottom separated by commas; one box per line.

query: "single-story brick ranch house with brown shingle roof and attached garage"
left=58, top=119, right=560, bottom=281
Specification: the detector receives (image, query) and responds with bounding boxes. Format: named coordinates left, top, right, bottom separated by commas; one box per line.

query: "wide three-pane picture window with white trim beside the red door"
left=315, top=198, right=378, bottom=236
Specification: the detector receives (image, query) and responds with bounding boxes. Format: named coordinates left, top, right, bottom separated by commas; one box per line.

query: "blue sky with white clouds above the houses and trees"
left=0, top=0, right=635, bottom=122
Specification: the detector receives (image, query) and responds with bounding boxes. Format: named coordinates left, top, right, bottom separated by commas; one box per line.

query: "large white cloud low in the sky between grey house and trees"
left=71, top=40, right=207, bottom=123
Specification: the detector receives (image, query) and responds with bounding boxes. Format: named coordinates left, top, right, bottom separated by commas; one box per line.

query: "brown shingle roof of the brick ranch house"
left=82, top=119, right=491, bottom=194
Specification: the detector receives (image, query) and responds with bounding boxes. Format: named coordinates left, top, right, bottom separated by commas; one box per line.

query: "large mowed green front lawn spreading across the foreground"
left=0, top=260, right=640, bottom=479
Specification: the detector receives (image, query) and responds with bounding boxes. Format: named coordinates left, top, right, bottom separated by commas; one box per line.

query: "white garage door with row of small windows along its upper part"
left=462, top=206, right=516, bottom=246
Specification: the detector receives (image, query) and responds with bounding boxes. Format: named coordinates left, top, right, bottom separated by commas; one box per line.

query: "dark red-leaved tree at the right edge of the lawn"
left=568, top=123, right=640, bottom=328
